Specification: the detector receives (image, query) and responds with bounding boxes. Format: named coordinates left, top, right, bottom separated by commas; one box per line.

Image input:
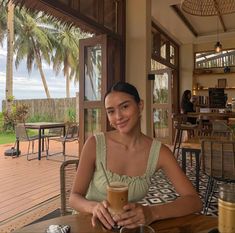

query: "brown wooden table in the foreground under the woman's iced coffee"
left=14, top=213, right=218, bottom=233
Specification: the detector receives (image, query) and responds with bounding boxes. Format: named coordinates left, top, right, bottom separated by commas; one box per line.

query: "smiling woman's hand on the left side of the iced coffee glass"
left=91, top=201, right=114, bottom=229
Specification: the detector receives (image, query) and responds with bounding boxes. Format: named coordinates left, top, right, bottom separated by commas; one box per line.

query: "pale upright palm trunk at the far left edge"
left=5, top=0, right=14, bottom=112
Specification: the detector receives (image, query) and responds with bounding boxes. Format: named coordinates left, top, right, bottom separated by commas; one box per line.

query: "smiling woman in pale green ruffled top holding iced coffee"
left=70, top=82, right=202, bottom=229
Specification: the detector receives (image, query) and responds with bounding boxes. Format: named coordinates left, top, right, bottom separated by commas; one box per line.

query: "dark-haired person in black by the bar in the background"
left=181, top=90, right=196, bottom=124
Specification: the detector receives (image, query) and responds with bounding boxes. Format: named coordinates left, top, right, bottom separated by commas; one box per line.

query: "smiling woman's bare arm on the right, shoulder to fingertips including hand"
left=114, top=145, right=202, bottom=228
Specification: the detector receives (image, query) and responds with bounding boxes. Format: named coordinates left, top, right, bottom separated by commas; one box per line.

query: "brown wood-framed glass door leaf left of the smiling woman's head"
left=79, top=35, right=107, bottom=151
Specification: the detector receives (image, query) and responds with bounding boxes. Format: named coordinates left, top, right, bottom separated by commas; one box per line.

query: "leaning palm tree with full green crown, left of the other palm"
left=14, top=8, right=54, bottom=98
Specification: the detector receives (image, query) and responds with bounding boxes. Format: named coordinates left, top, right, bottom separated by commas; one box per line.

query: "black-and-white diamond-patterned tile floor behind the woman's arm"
left=140, top=157, right=218, bottom=216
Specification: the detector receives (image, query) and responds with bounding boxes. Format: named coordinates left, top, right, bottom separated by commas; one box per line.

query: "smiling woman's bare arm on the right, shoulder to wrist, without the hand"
left=150, top=145, right=202, bottom=221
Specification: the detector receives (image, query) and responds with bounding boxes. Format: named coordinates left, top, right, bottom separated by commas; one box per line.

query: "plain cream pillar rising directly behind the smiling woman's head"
left=126, top=0, right=151, bottom=135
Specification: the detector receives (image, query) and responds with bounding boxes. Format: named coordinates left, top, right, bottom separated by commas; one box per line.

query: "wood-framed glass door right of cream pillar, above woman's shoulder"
left=151, top=68, right=172, bottom=144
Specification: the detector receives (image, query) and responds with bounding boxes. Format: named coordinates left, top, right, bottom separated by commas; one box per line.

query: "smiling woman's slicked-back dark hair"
left=104, top=82, right=140, bottom=103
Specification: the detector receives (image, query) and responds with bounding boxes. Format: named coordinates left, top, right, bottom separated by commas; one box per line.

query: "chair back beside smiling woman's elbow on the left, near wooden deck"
left=60, top=159, right=79, bottom=216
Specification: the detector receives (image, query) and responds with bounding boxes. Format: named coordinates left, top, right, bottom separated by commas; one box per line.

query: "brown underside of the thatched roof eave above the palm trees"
left=12, top=0, right=95, bottom=33
